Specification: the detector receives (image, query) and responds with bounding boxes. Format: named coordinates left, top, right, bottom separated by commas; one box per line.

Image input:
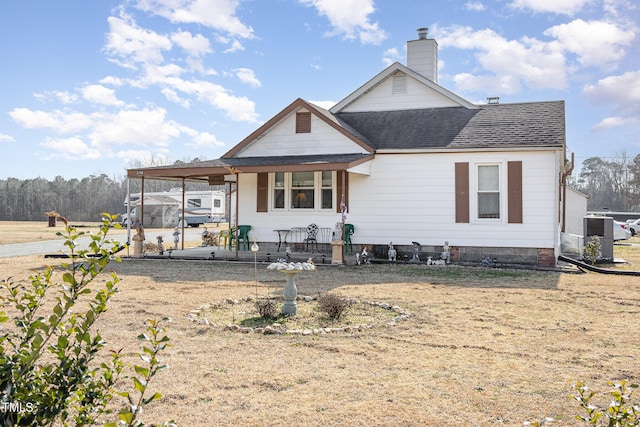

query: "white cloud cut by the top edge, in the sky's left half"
left=135, top=0, right=253, bottom=39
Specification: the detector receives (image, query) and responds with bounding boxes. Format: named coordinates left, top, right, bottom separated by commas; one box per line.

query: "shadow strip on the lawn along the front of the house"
left=111, top=259, right=562, bottom=294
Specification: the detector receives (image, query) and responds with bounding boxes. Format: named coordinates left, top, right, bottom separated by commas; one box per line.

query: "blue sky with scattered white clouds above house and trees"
left=0, top=0, right=640, bottom=179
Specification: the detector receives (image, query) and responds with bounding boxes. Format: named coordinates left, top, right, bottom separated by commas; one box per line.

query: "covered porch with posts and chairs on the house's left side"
left=127, top=154, right=373, bottom=261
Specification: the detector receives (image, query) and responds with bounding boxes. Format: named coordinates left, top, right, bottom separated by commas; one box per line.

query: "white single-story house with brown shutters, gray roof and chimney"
left=128, top=29, right=574, bottom=266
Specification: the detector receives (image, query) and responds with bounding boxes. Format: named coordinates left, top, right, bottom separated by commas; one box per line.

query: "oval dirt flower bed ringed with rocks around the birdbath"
left=186, top=294, right=410, bottom=335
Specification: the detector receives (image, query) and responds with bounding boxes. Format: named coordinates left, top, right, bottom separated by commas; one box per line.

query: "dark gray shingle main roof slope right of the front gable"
left=335, top=101, right=565, bottom=150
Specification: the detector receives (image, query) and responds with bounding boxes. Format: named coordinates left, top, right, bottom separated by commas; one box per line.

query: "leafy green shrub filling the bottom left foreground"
left=0, top=214, right=172, bottom=427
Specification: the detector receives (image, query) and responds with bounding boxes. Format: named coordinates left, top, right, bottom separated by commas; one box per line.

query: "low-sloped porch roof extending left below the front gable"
left=127, top=153, right=374, bottom=183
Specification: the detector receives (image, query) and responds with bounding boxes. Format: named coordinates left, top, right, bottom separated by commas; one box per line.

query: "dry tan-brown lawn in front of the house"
left=0, top=223, right=640, bottom=426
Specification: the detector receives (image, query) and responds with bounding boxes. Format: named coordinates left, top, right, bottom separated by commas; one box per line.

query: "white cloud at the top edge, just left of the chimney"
left=298, top=0, right=388, bottom=45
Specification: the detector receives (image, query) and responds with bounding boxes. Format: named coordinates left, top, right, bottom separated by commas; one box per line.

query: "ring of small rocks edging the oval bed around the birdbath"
left=185, top=295, right=411, bottom=335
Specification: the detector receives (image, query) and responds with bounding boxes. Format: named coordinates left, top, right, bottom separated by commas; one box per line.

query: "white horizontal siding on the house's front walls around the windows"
left=238, top=150, right=562, bottom=248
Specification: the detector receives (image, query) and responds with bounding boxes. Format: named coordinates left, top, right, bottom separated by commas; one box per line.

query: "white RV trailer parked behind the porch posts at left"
left=122, top=188, right=226, bottom=228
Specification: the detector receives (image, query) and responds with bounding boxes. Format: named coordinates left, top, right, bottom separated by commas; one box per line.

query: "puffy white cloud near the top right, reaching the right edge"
left=544, top=19, right=635, bottom=67
